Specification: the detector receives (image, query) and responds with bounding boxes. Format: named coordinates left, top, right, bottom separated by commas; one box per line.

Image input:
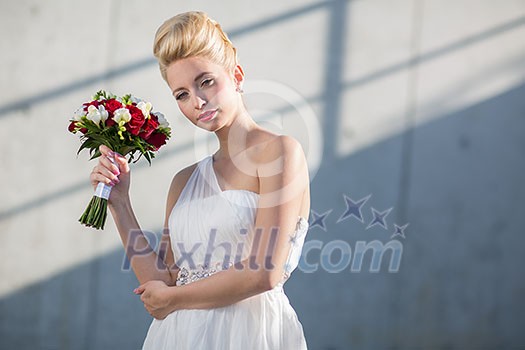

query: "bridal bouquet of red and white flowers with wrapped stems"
left=68, top=90, right=171, bottom=229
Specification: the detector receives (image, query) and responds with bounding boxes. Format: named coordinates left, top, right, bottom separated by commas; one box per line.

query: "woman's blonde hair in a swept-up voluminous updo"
left=153, top=11, right=238, bottom=81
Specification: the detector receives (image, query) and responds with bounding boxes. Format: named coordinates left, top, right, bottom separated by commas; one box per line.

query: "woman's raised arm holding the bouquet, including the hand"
left=91, top=146, right=182, bottom=285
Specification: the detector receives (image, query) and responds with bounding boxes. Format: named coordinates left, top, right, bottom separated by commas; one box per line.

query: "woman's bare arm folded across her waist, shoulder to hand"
left=135, top=136, right=308, bottom=319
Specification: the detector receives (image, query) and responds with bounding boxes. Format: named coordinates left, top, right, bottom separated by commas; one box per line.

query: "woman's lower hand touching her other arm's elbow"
left=133, top=281, right=174, bottom=320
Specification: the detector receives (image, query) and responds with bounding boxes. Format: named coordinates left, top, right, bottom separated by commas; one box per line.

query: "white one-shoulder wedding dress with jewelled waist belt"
left=143, top=155, right=308, bottom=350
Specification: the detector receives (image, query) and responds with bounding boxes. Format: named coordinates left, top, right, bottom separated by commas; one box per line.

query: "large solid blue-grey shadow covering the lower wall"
left=0, top=80, right=525, bottom=349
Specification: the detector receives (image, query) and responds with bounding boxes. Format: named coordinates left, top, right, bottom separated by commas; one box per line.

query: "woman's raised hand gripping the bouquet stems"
left=90, top=145, right=131, bottom=204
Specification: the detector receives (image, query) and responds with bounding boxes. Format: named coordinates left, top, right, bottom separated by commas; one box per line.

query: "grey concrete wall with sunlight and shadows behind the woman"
left=0, top=0, right=525, bottom=350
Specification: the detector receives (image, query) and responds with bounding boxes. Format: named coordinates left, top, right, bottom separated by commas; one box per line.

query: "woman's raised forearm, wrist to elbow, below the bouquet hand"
left=109, top=198, right=177, bottom=286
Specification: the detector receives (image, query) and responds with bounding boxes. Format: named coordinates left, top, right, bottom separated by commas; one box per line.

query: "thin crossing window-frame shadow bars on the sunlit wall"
left=0, top=6, right=525, bottom=221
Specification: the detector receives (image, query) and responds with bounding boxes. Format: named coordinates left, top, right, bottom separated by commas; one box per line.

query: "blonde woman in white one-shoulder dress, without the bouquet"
left=91, top=12, right=310, bottom=350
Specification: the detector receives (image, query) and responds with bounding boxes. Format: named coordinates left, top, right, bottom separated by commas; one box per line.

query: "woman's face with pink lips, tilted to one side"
left=166, top=57, right=241, bottom=131
